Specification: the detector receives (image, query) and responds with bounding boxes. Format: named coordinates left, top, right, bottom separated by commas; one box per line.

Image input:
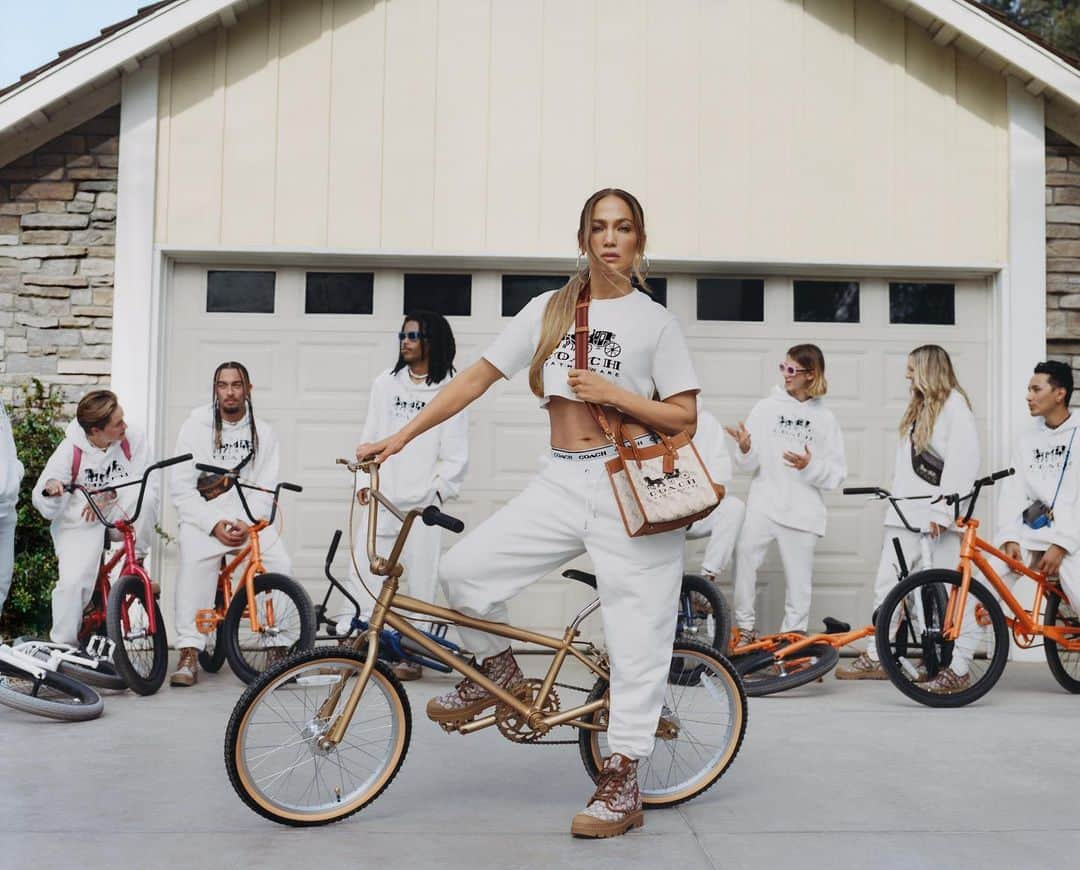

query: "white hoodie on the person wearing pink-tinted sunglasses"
left=732, top=386, right=848, bottom=535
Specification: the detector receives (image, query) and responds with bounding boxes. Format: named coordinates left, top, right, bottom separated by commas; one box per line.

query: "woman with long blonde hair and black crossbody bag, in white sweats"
left=836, top=344, right=980, bottom=690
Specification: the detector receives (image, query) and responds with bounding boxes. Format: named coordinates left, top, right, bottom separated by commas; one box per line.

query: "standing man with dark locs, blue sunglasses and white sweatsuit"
left=336, top=311, right=469, bottom=680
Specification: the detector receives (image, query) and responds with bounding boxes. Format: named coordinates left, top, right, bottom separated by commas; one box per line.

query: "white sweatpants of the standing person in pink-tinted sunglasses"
left=734, top=508, right=818, bottom=631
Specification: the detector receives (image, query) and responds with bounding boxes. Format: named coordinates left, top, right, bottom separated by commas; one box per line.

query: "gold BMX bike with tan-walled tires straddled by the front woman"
left=225, top=460, right=746, bottom=826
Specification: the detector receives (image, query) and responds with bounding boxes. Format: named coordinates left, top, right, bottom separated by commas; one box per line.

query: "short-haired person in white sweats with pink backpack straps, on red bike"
left=32, top=390, right=157, bottom=645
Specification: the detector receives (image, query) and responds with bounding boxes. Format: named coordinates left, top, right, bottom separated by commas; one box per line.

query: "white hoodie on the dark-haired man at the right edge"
left=996, top=414, right=1080, bottom=553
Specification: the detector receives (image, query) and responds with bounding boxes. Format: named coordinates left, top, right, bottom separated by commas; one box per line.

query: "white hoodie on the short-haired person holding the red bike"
left=32, top=420, right=157, bottom=533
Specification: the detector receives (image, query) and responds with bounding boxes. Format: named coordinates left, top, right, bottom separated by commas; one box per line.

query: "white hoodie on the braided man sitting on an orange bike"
left=171, top=405, right=281, bottom=535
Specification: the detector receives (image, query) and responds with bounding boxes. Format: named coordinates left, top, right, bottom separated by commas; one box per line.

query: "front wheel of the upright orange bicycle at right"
left=875, top=569, right=1009, bottom=707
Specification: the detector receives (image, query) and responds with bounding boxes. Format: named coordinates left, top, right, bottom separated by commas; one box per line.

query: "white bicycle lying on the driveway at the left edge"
left=0, top=643, right=105, bottom=722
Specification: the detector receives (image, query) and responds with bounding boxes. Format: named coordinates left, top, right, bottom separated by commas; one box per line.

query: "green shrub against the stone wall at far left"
left=0, top=380, right=64, bottom=637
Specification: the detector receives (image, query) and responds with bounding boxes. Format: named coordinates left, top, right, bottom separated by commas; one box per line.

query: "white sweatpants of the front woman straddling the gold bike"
left=440, top=459, right=686, bottom=759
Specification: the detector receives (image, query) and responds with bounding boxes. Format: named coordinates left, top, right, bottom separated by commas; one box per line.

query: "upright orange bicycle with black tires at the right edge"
left=876, top=468, right=1080, bottom=707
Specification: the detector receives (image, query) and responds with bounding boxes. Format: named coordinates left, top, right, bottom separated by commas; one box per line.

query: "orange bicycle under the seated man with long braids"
left=195, top=462, right=315, bottom=683
